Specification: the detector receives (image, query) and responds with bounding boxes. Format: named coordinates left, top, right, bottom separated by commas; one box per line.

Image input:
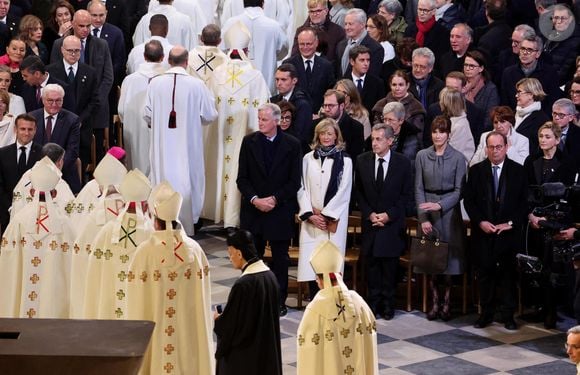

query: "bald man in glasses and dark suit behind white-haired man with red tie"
left=47, top=35, right=100, bottom=170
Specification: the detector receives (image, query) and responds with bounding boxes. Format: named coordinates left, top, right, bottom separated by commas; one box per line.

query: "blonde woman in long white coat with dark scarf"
left=298, top=118, right=352, bottom=299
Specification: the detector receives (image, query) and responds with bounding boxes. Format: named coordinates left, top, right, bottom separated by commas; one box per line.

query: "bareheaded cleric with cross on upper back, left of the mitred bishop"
left=187, top=24, right=229, bottom=87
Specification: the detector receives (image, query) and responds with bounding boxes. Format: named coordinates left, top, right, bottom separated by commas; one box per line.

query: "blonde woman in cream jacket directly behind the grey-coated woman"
left=439, top=87, right=475, bottom=163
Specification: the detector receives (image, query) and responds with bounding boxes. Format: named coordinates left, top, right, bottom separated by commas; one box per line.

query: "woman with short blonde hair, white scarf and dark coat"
left=514, top=78, right=550, bottom=155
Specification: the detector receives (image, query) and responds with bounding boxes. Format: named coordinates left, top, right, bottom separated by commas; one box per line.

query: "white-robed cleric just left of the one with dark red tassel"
left=117, top=40, right=164, bottom=175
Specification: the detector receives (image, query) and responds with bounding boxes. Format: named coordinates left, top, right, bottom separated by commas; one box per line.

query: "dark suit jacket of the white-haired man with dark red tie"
left=30, top=108, right=81, bottom=194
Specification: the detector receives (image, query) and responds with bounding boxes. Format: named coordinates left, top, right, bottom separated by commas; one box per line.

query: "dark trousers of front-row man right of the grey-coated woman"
left=477, top=262, right=517, bottom=319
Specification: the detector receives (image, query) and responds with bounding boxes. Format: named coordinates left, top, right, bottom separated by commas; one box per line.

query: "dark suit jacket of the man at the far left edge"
left=0, top=142, right=42, bottom=233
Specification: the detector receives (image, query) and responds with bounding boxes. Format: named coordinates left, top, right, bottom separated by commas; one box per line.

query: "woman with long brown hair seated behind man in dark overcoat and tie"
left=372, top=70, right=425, bottom=135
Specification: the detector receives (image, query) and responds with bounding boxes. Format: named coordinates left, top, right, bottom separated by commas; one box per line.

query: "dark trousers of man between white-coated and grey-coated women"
left=366, top=256, right=399, bottom=314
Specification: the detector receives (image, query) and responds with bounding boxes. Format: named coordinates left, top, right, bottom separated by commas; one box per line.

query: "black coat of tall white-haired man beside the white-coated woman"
left=236, top=128, right=302, bottom=240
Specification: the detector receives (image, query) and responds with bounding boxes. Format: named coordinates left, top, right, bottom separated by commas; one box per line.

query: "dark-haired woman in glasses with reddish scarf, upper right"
left=463, top=50, right=499, bottom=130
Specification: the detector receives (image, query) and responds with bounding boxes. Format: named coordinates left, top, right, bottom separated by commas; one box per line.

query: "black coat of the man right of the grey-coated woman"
left=463, top=158, right=528, bottom=270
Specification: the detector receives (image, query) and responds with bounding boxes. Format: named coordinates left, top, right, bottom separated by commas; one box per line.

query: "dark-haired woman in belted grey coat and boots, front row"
left=415, top=116, right=466, bottom=321
